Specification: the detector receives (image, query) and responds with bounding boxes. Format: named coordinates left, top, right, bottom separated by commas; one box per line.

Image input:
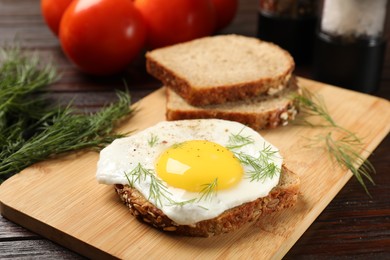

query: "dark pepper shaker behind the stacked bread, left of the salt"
left=257, top=0, right=317, bottom=65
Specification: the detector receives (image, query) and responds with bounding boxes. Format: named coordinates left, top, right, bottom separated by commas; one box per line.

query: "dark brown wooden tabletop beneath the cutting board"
left=0, top=0, right=390, bottom=259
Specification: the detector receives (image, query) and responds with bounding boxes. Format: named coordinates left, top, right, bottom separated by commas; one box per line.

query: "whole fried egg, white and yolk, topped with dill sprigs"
left=96, top=119, right=283, bottom=225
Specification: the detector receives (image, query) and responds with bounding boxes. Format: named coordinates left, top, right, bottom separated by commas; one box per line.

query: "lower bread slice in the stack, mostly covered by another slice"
left=166, top=77, right=299, bottom=130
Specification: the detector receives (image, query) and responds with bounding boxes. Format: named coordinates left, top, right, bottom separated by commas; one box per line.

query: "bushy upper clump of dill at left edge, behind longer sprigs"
left=0, top=48, right=58, bottom=134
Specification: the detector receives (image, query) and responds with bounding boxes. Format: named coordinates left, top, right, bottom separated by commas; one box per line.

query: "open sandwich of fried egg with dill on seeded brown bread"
left=96, top=119, right=299, bottom=237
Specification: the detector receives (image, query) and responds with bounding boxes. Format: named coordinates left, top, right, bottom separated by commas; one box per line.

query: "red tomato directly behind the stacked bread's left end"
left=134, top=0, right=215, bottom=48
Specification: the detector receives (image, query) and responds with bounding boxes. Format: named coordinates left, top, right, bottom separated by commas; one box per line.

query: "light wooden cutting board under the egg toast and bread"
left=0, top=78, right=390, bottom=259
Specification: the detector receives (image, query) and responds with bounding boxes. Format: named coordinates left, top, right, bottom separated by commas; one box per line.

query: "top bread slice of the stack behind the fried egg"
left=146, top=34, right=295, bottom=106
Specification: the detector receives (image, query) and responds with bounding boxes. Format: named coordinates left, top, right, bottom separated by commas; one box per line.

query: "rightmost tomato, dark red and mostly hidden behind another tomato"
left=211, top=0, right=238, bottom=30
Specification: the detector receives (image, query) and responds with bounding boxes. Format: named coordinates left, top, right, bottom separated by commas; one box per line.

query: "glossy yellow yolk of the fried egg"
left=155, top=140, right=243, bottom=192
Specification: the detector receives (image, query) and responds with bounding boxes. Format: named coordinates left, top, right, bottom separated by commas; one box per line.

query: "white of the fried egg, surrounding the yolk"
left=96, top=119, right=283, bottom=225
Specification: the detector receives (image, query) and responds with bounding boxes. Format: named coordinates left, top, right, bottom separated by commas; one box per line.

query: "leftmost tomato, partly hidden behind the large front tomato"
left=41, top=0, right=73, bottom=36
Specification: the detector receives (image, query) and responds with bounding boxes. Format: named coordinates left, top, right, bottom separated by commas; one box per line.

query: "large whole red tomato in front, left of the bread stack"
left=60, top=0, right=146, bottom=75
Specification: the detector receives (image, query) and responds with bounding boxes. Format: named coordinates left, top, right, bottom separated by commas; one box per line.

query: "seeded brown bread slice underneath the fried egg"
left=115, top=165, right=300, bottom=237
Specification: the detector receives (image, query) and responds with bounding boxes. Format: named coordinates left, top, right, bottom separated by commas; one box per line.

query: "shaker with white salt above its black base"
left=313, top=0, right=387, bottom=93
